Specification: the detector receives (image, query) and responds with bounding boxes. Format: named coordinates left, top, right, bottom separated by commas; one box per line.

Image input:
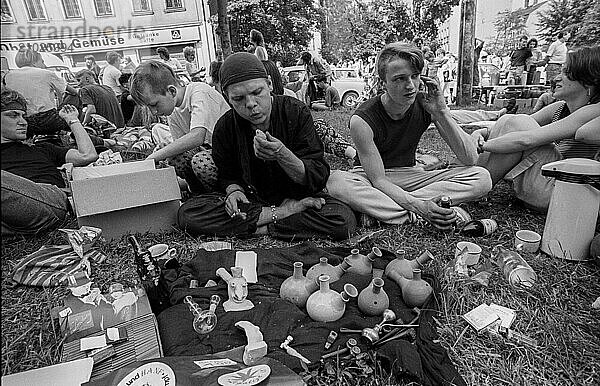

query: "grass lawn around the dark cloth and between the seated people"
left=1, top=106, right=600, bottom=385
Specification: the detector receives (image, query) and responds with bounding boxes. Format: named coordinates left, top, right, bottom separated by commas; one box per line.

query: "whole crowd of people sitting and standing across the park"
left=0, top=34, right=600, bottom=239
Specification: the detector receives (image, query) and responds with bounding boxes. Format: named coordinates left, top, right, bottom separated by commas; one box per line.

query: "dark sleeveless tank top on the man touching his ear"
left=354, top=95, right=431, bottom=169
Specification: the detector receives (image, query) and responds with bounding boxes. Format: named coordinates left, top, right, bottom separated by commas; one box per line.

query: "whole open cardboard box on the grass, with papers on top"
left=71, top=161, right=181, bottom=240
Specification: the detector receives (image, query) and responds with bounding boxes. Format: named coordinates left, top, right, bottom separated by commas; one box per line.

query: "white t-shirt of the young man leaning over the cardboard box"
left=169, top=82, right=230, bottom=145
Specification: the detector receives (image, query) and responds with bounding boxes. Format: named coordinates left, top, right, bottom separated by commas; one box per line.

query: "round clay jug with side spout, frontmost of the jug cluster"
left=306, top=275, right=358, bottom=322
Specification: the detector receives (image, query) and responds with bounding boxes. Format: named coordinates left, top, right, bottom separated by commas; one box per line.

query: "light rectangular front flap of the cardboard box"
left=71, top=167, right=181, bottom=217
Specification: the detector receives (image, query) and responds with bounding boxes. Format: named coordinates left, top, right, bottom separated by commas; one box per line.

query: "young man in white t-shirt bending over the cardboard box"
left=130, top=60, right=230, bottom=193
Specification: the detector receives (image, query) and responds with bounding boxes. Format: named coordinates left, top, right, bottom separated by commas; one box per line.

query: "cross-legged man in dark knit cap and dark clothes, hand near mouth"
left=178, top=53, right=356, bottom=240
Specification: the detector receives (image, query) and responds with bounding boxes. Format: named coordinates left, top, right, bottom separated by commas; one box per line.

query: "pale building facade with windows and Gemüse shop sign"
left=0, top=0, right=216, bottom=68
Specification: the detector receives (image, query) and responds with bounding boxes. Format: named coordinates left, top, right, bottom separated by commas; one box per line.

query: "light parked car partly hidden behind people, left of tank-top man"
left=283, top=66, right=365, bottom=107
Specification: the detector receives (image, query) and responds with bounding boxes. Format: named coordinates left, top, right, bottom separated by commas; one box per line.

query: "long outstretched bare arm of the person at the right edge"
left=482, top=104, right=600, bottom=153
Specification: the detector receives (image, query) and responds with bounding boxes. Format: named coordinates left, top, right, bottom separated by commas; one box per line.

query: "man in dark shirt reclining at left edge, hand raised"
left=0, top=89, right=98, bottom=237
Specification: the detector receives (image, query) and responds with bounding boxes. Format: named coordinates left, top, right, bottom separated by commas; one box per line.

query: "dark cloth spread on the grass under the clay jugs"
left=158, top=242, right=465, bottom=385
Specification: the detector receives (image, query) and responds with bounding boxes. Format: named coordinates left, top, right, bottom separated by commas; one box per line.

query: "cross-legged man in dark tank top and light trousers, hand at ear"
left=327, top=43, right=491, bottom=229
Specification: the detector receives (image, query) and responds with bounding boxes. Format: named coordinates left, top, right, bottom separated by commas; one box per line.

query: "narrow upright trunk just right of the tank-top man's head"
left=456, top=0, right=477, bottom=106
